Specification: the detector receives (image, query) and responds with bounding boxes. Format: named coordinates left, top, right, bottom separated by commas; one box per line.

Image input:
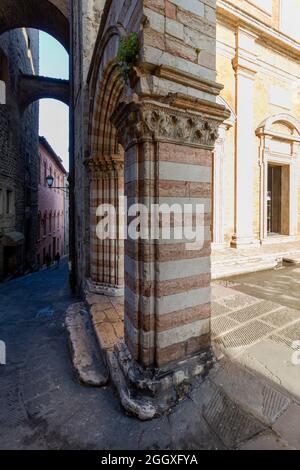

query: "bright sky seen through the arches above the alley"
left=39, top=31, right=69, bottom=170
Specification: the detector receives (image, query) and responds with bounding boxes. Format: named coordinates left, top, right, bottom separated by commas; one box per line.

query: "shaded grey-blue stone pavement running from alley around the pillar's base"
left=0, top=264, right=300, bottom=450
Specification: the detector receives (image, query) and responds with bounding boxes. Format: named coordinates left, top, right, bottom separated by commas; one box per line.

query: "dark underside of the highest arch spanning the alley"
left=0, top=0, right=70, bottom=50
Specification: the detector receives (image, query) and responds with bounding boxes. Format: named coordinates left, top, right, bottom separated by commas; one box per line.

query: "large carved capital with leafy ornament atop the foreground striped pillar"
left=111, top=101, right=223, bottom=150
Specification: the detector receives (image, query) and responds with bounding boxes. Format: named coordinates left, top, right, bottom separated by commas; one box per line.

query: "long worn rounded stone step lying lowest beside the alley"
left=65, top=302, right=108, bottom=387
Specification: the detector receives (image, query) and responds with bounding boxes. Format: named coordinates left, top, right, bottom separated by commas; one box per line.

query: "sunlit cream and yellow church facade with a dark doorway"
left=212, top=0, right=300, bottom=253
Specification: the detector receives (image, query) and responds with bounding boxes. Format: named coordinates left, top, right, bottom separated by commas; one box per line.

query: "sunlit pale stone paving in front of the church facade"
left=212, top=266, right=300, bottom=400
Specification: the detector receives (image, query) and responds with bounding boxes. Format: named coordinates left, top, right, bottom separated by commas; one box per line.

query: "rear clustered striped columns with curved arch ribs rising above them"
left=87, top=61, right=124, bottom=295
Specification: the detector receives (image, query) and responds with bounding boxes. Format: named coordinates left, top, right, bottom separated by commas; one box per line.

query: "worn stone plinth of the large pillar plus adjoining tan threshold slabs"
left=86, top=293, right=217, bottom=420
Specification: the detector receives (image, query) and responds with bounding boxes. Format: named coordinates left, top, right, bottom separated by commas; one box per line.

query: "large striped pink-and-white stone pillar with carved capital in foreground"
left=113, top=102, right=224, bottom=369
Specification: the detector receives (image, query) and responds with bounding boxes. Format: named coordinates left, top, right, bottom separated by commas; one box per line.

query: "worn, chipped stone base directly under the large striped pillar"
left=107, top=340, right=214, bottom=420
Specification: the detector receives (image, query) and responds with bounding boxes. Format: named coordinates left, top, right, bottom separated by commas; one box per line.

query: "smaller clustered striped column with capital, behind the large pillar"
left=88, top=155, right=124, bottom=295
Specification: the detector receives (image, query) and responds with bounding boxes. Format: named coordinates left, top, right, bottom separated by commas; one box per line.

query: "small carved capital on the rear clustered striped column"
left=86, top=154, right=124, bottom=179
